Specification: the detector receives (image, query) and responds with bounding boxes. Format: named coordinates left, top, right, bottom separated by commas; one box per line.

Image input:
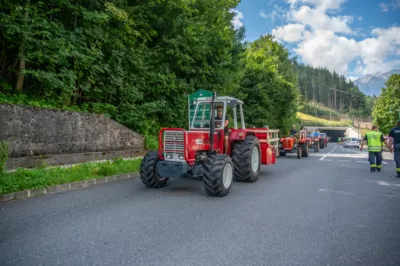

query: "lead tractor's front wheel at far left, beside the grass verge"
left=140, top=151, right=169, bottom=188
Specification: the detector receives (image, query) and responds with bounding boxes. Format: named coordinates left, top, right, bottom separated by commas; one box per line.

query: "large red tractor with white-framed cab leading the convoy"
left=140, top=93, right=279, bottom=197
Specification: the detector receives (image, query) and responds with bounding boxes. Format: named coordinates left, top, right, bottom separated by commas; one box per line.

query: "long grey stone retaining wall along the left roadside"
left=0, top=104, right=144, bottom=157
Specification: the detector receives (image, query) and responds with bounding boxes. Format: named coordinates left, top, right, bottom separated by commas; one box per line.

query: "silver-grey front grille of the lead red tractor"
left=164, top=130, right=185, bottom=161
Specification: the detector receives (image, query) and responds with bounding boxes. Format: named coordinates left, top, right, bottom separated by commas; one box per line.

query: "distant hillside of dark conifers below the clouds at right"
left=293, top=60, right=376, bottom=118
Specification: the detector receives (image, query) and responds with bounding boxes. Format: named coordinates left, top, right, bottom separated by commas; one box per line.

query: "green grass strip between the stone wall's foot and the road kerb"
left=0, top=158, right=142, bottom=195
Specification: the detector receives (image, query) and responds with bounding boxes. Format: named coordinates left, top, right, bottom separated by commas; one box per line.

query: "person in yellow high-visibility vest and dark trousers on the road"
left=360, top=125, right=389, bottom=172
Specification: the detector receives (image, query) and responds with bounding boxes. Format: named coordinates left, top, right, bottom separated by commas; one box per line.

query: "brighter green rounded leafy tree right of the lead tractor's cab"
left=236, top=35, right=298, bottom=131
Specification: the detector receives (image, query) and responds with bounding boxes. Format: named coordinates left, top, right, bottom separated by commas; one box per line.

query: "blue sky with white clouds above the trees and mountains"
left=234, top=0, right=400, bottom=80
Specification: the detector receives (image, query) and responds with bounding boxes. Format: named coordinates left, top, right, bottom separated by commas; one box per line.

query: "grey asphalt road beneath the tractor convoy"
left=0, top=144, right=400, bottom=266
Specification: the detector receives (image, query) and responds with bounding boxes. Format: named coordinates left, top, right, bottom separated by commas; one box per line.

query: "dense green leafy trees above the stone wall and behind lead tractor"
left=0, top=0, right=297, bottom=139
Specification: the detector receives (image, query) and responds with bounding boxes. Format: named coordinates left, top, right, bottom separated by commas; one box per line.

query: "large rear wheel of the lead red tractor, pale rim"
left=232, top=135, right=262, bottom=182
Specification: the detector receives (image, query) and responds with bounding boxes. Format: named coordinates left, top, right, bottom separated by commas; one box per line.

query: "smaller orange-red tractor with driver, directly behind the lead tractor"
left=280, top=130, right=311, bottom=159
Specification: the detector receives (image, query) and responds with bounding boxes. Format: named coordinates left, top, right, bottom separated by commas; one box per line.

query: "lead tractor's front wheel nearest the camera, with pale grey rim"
left=203, top=154, right=234, bottom=197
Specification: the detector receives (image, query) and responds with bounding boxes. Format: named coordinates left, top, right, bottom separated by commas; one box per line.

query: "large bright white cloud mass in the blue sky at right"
left=272, top=0, right=400, bottom=78
